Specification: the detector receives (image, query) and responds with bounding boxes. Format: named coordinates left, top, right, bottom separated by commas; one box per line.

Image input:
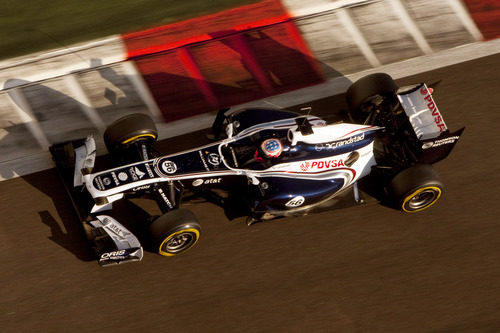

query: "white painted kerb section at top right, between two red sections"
left=284, top=0, right=482, bottom=76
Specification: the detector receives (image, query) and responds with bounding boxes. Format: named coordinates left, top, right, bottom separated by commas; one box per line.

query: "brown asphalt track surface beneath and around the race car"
left=0, top=54, right=500, bottom=332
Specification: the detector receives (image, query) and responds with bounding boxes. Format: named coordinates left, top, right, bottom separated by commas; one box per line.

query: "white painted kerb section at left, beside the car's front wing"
left=0, top=37, right=161, bottom=179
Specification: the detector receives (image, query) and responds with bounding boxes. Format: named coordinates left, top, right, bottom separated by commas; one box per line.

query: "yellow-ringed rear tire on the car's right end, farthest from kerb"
left=389, top=164, right=443, bottom=213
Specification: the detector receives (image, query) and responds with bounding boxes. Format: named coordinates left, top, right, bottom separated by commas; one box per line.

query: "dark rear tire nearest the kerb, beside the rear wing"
left=346, top=73, right=399, bottom=121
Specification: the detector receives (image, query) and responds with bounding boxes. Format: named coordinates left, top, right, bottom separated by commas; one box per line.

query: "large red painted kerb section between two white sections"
left=123, top=0, right=324, bottom=121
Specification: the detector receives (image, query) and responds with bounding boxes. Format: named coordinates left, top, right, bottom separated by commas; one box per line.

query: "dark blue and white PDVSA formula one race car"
left=50, top=73, right=463, bottom=265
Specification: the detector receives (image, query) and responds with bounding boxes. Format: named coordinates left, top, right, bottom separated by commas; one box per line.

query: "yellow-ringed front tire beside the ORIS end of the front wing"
left=149, top=209, right=201, bottom=257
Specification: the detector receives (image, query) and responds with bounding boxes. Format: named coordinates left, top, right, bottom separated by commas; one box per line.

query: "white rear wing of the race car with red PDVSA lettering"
left=397, top=83, right=465, bottom=163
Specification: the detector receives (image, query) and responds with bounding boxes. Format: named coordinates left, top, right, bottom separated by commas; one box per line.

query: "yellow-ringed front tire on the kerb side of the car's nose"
left=104, top=113, right=158, bottom=153
